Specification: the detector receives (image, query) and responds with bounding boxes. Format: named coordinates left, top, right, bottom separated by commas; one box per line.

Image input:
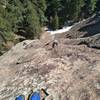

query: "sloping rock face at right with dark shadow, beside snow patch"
left=56, top=14, right=100, bottom=49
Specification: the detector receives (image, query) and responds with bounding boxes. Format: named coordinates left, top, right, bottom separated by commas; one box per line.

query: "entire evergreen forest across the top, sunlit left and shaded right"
left=0, top=0, right=100, bottom=54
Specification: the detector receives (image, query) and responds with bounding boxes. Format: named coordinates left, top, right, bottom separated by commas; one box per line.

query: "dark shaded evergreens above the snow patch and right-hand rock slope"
left=46, top=0, right=100, bottom=26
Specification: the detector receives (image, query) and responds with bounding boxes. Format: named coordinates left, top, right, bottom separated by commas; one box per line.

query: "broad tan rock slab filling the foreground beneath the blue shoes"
left=0, top=34, right=100, bottom=100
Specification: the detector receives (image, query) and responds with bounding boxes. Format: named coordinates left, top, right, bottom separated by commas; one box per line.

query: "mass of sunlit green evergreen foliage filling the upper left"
left=0, top=0, right=42, bottom=40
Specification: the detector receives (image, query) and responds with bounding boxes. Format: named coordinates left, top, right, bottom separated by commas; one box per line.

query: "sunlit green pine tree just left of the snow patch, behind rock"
left=18, top=1, right=40, bottom=39
